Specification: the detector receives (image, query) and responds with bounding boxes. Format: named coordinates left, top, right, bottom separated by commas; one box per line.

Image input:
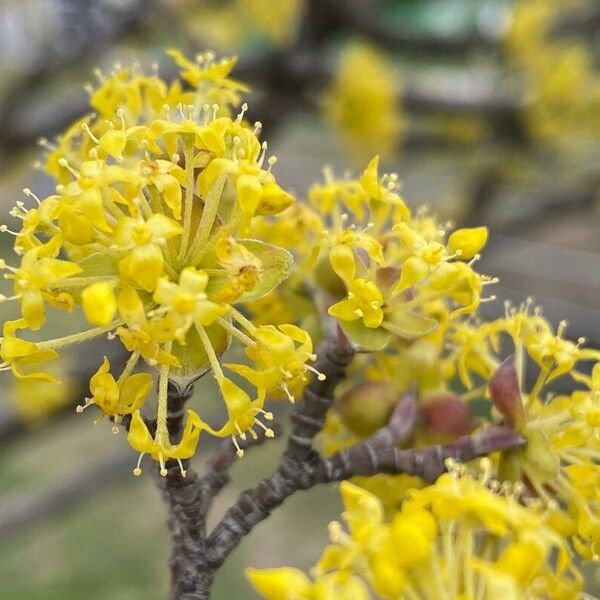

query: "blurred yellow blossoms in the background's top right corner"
left=505, top=0, right=600, bottom=143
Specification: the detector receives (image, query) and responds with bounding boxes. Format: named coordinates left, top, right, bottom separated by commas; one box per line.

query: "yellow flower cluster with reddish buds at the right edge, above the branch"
left=314, top=290, right=600, bottom=560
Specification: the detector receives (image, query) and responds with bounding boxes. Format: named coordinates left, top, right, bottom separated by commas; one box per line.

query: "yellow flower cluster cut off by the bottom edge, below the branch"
left=247, top=474, right=581, bottom=600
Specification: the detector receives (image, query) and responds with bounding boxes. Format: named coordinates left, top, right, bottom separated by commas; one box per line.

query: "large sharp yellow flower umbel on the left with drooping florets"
left=0, top=50, right=302, bottom=473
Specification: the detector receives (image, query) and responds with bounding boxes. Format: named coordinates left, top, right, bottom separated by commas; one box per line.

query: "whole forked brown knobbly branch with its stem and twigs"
left=157, top=336, right=524, bottom=600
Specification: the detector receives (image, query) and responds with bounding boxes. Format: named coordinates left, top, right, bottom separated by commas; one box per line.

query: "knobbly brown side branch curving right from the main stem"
left=207, top=379, right=524, bottom=569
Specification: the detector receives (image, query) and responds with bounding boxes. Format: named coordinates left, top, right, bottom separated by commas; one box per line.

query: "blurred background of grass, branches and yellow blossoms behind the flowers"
left=0, top=0, right=600, bottom=600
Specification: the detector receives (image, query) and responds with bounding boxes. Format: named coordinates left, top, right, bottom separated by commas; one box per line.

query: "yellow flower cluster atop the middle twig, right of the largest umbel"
left=254, top=157, right=496, bottom=360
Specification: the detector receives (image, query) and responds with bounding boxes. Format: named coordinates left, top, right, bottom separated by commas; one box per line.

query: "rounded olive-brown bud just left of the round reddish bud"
left=334, top=381, right=402, bottom=437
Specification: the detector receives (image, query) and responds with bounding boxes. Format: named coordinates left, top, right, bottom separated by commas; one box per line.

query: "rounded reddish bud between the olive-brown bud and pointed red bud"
left=419, top=393, right=476, bottom=438
